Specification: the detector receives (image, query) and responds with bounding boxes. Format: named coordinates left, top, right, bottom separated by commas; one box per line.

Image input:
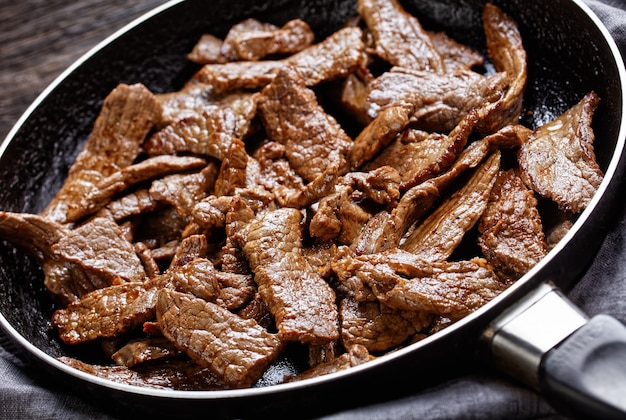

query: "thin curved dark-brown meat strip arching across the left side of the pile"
left=66, top=156, right=206, bottom=222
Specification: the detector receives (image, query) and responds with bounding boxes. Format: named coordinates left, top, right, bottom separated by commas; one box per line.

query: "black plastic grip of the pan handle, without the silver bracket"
left=540, top=315, right=626, bottom=419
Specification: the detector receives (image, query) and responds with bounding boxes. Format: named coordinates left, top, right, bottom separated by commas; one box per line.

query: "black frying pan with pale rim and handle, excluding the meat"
left=0, top=0, right=626, bottom=418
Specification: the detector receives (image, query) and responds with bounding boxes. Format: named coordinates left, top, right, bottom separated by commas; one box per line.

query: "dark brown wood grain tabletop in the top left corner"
left=0, top=0, right=165, bottom=141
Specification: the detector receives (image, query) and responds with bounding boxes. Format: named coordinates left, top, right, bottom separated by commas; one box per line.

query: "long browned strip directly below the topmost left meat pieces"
left=192, top=27, right=365, bottom=92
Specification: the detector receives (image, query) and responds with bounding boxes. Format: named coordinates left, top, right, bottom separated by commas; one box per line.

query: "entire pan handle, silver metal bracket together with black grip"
left=483, top=283, right=626, bottom=419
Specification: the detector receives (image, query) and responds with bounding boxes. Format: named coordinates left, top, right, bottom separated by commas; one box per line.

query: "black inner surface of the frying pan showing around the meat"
left=0, top=0, right=623, bottom=414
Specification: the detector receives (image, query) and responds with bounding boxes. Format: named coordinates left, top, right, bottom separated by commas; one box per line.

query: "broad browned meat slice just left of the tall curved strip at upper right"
left=369, top=67, right=507, bottom=133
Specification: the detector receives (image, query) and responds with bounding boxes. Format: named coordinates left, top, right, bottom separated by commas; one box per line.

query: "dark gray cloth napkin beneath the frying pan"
left=0, top=0, right=626, bottom=420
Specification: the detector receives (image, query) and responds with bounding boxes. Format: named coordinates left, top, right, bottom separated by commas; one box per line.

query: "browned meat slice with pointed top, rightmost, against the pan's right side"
left=518, top=92, right=603, bottom=213
